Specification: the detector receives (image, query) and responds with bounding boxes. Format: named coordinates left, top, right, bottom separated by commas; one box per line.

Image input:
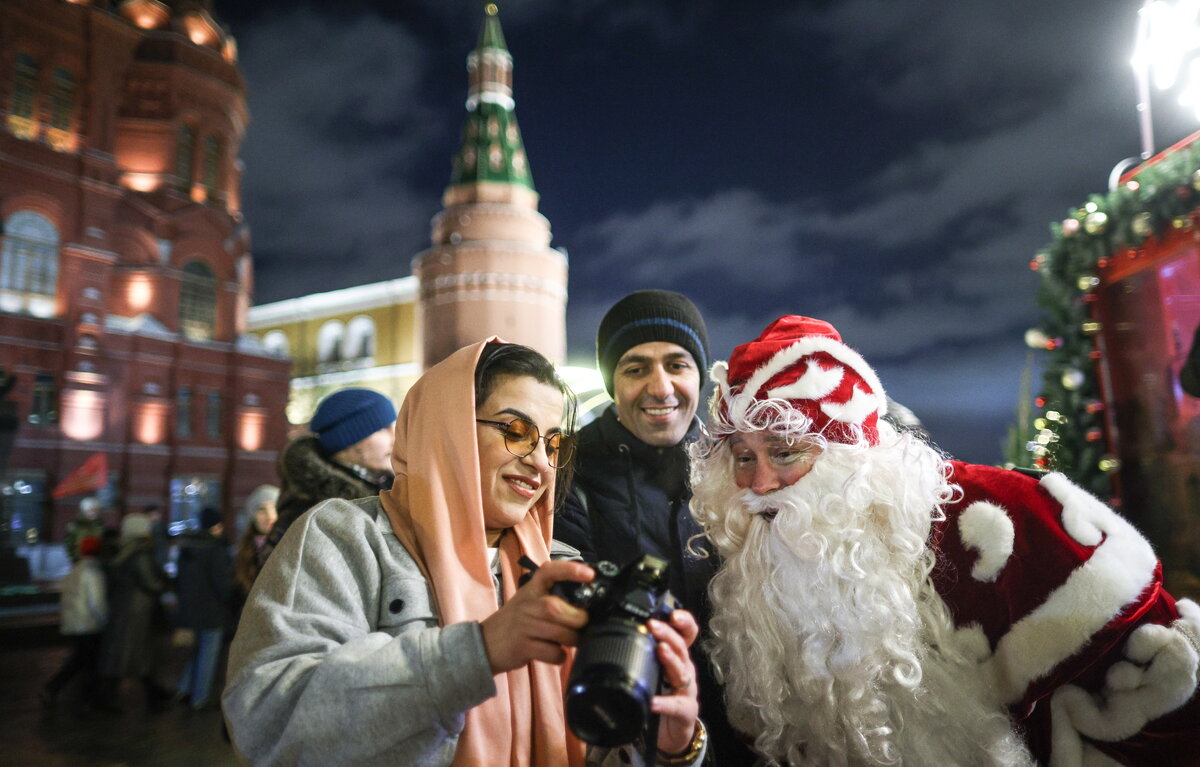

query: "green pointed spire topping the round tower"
left=450, top=2, right=533, bottom=190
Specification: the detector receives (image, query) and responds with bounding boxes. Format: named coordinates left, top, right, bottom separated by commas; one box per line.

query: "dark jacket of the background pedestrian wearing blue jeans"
left=175, top=531, right=233, bottom=631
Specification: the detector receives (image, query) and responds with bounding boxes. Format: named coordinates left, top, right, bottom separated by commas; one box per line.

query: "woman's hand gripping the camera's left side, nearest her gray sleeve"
left=480, top=561, right=590, bottom=673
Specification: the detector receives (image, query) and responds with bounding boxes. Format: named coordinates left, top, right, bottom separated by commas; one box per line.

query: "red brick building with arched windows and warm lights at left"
left=0, top=0, right=288, bottom=546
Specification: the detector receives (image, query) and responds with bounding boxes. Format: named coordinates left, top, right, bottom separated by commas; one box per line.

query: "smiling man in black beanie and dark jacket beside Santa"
left=556, top=290, right=754, bottom=767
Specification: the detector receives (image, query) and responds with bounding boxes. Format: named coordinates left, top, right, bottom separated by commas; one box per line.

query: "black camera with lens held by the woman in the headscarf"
left=551, top=555, right=679, bottom=747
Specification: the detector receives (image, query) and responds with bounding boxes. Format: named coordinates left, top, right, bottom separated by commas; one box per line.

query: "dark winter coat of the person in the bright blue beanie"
left=258, top=435, right=391, bottom=565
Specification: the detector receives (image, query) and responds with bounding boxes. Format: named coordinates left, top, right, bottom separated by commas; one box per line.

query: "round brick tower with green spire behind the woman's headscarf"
left=413, top=4, right=566, bottom=367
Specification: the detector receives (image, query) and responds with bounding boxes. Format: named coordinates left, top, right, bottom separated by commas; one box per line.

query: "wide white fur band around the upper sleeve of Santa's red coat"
left=991, top=474, right=1158, bottom=705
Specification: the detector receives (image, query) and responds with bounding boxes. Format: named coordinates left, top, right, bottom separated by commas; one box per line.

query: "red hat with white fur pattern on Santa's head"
left=713, top=314, right=887, bottom=445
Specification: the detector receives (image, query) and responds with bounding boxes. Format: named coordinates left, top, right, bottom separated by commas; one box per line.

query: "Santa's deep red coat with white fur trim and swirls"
left=934, top=461, right=1200, bottom=767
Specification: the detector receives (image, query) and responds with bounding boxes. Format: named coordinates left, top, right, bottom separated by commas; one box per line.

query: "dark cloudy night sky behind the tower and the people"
left=208, top=0, right=1194, bottom=463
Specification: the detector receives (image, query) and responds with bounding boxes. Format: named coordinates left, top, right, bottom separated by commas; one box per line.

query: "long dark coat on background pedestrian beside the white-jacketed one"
left=100, top=538, right=167, bottom=677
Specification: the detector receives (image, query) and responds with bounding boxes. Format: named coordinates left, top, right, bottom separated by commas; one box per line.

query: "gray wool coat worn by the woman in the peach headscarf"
left=222, top=496, right=703, bottom=767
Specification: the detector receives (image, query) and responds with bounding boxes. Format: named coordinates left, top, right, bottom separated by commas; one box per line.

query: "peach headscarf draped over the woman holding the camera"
left=380, top=338, right=583, bottom=767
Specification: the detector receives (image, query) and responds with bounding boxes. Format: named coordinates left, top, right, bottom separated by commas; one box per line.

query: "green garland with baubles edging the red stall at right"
left=1007, top=135, right=1200, bottom=498
